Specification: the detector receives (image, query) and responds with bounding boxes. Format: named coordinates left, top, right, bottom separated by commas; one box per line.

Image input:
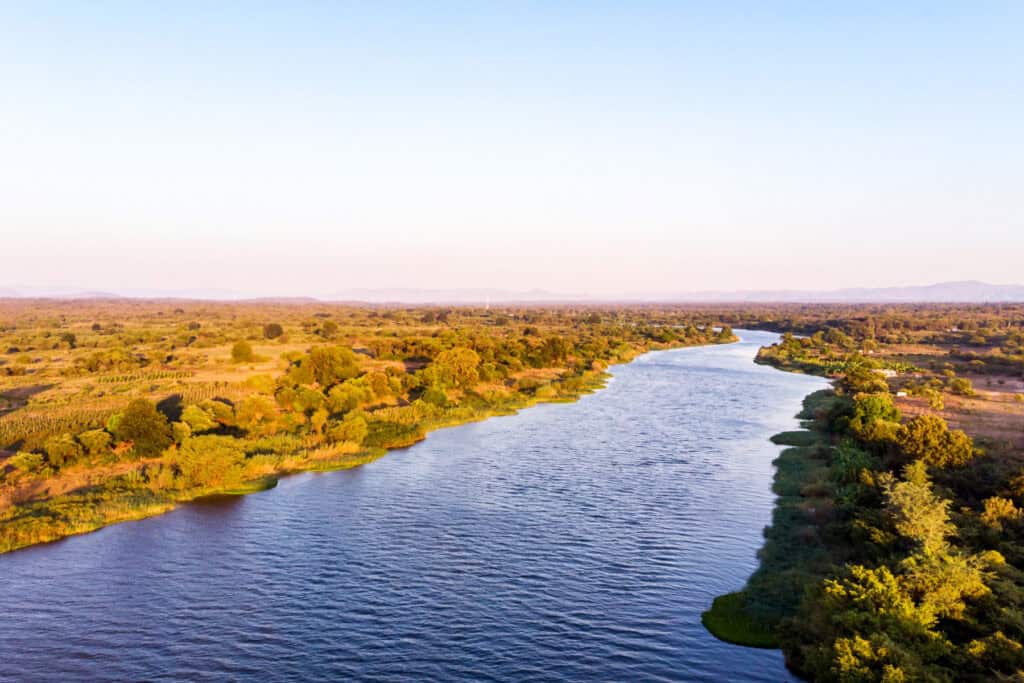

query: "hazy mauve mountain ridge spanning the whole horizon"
left=0, top=280, right=1024, bottom=304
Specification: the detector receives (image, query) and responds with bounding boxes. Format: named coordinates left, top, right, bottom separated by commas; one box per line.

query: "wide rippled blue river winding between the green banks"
left=0, top=331, right=824, bottom=681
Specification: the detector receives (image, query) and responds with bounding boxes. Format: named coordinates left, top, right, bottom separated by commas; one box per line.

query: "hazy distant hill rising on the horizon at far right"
left=663, top=280, right=1024, bottom=303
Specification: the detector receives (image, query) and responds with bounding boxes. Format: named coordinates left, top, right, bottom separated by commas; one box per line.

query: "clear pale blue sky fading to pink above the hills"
left=0, top=0, right=1024, bottom=297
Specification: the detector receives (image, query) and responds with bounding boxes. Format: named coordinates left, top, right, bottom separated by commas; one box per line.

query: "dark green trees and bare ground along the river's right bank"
left=703, top=306, right=1024, bottom=682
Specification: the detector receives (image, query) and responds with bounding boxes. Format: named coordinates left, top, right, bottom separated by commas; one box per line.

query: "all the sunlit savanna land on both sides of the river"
left=0, top=300, right=1024, bottom=681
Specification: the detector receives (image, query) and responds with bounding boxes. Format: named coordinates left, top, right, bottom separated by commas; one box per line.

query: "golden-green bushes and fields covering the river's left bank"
left=0, top=301, right=735, bottom=552
